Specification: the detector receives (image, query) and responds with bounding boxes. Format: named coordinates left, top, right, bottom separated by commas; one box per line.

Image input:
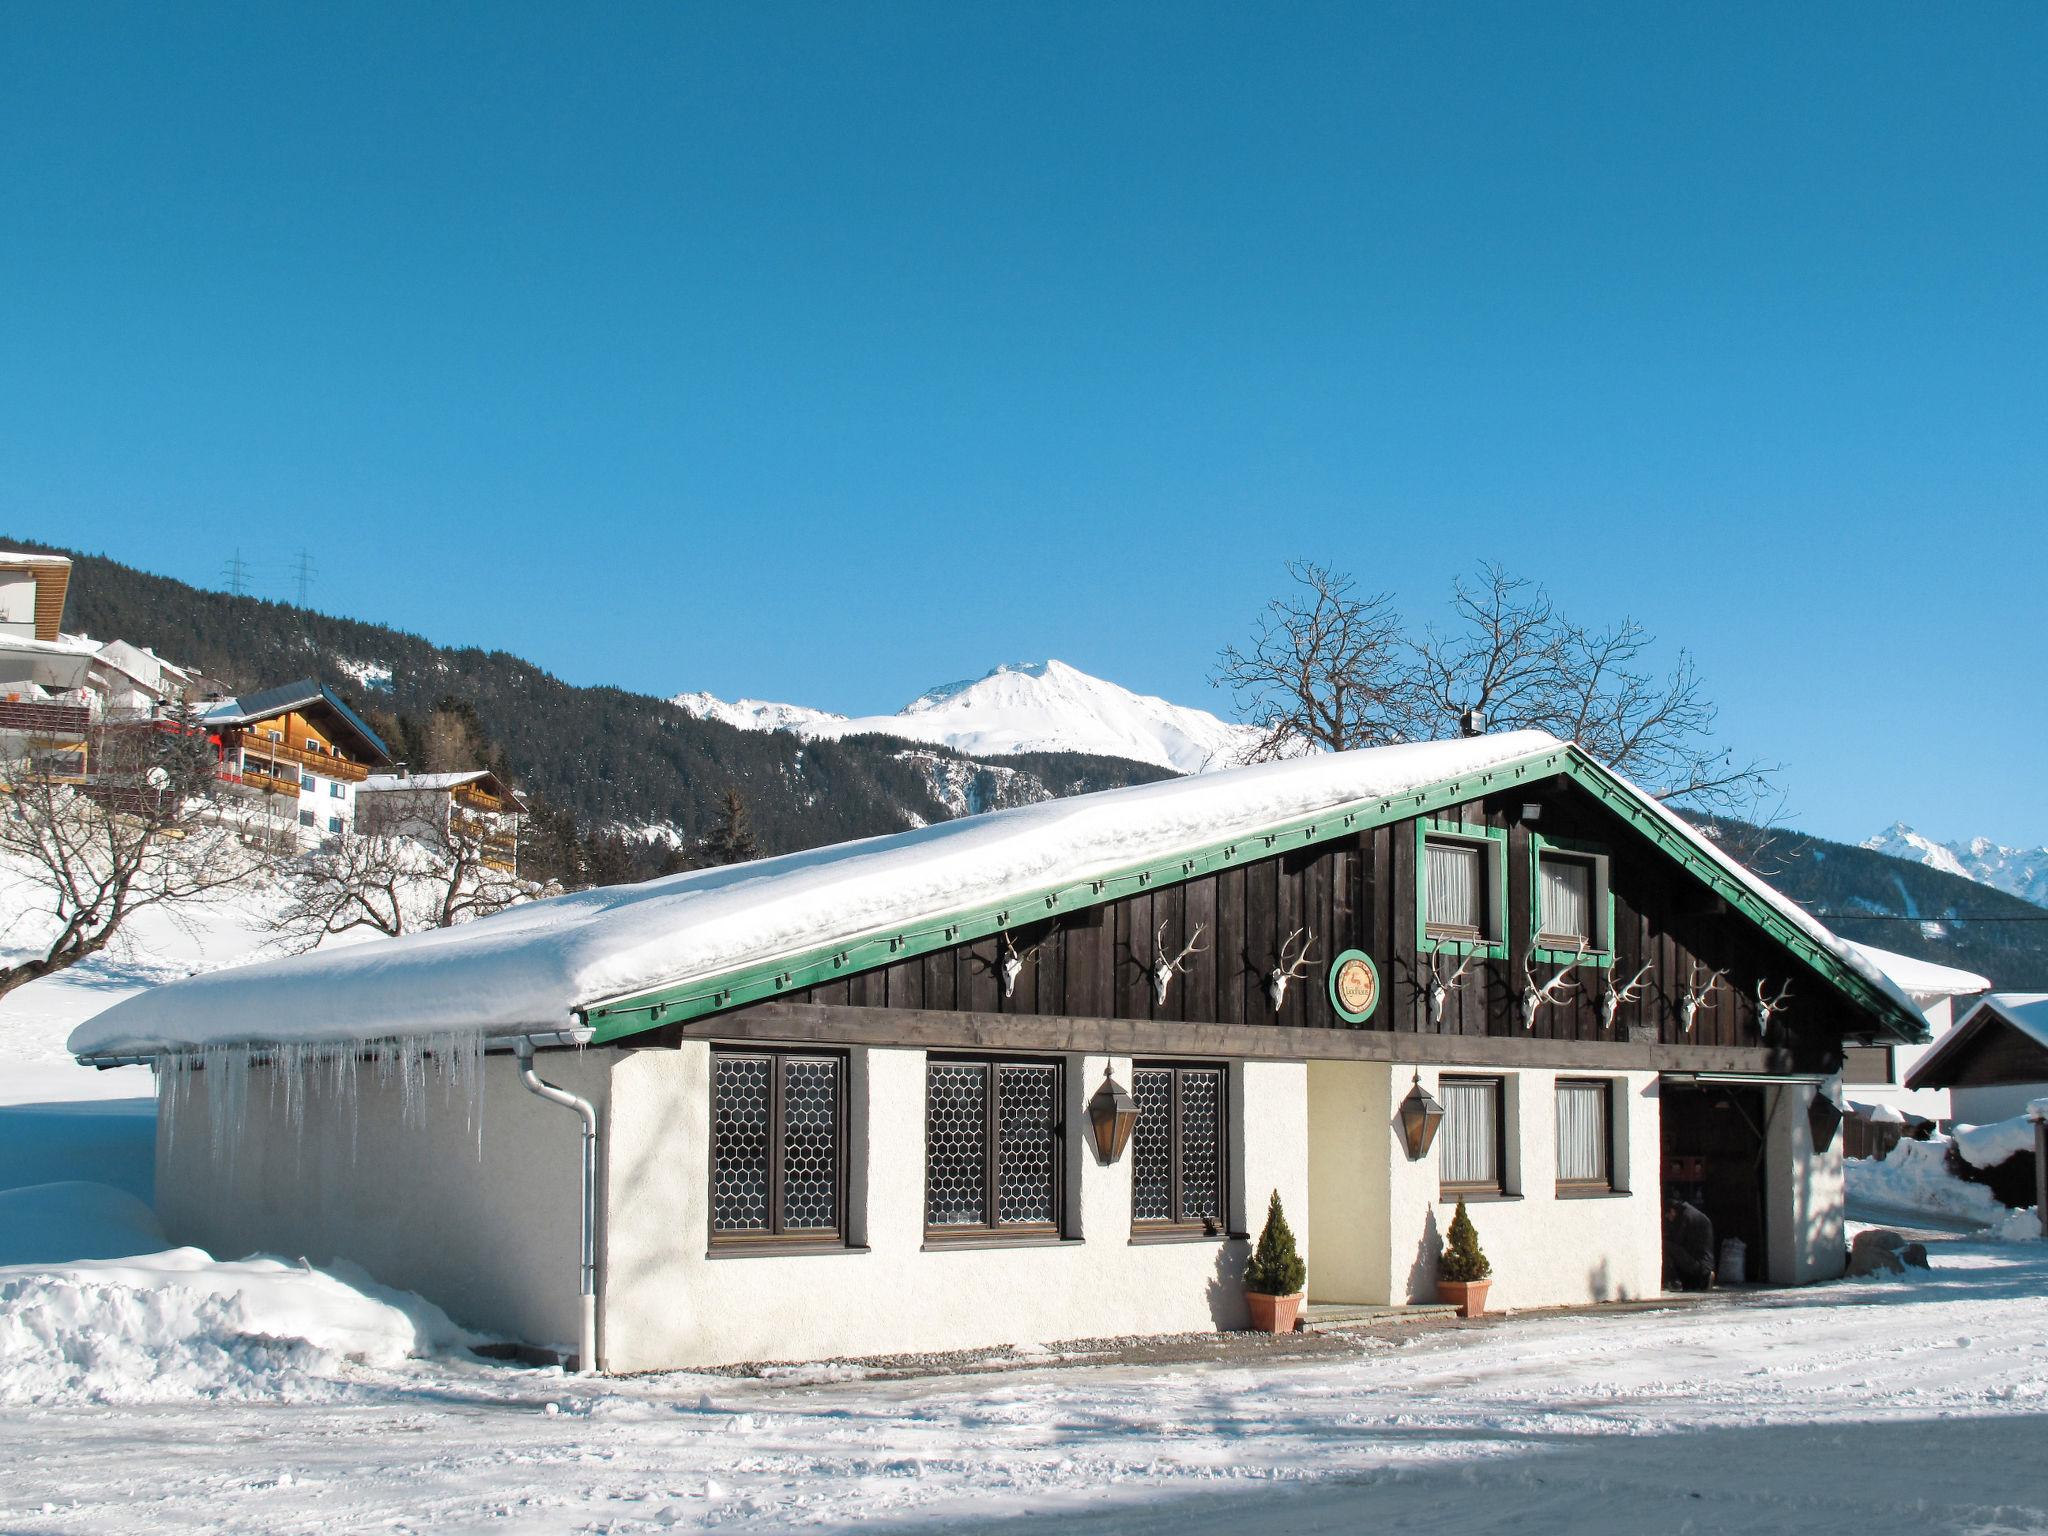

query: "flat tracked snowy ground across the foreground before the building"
left=0, top=1239, right=2048, bottom=1536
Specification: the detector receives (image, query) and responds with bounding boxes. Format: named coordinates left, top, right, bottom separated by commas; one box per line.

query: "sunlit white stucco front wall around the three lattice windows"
left=600, top=1040, right=1313, bottom=1372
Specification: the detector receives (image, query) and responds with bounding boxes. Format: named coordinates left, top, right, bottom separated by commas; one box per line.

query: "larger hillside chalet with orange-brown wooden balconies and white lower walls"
left=201, top=678, right=391, bottom=842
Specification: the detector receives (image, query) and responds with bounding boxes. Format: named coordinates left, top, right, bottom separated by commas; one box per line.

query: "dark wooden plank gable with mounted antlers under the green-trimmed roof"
left=716, top=776, right=1872, bottom=1069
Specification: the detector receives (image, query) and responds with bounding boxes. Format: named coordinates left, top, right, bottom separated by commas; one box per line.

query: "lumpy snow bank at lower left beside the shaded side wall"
left=0, top=1247, right=469, bottom=1403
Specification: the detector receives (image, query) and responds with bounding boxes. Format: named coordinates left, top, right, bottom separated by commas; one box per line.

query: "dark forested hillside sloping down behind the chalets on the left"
left=12, top=535, right=1169, bottom=852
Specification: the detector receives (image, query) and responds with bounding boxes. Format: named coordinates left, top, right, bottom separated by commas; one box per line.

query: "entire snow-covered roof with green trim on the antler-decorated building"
left=70, top=731, right=1925, bottom=1055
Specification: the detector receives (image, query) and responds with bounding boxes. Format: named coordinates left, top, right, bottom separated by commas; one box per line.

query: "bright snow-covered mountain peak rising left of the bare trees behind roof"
left=672, top=659, right=1260, bottom=774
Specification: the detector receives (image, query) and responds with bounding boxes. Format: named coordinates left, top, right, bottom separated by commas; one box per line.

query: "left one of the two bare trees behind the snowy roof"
left=1210, top=559, right=1411, bottom=762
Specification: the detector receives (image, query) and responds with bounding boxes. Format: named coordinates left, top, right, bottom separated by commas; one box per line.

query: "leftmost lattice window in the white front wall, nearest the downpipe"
left=711, top=1051, right=846, bottom=1247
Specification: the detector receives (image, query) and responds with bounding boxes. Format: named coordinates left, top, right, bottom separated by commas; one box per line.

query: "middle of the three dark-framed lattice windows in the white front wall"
left=924, top=1057, right=1065, bottom=1239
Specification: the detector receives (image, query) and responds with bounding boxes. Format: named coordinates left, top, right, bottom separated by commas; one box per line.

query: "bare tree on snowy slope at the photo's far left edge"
left=0, top=719, right=276, bottom=995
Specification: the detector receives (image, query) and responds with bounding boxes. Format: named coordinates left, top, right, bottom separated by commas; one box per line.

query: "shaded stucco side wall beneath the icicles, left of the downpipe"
left=156, top=1051, right=610, bottom=1346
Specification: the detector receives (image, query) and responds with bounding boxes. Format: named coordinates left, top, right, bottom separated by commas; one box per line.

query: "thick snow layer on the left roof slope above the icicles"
left=70, top=731, right=1556, bottom=1053
